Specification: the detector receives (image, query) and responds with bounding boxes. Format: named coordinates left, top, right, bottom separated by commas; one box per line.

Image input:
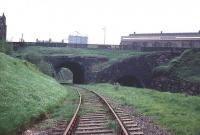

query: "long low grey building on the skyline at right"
left=120, top=31, right=200, bottom=50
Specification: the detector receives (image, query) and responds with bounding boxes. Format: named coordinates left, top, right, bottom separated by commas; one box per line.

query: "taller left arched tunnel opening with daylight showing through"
left=57, top=62, right=85, bottom=84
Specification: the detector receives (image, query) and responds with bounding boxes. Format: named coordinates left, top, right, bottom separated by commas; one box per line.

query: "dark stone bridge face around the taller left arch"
left=44, top=56, right=108, bottom=84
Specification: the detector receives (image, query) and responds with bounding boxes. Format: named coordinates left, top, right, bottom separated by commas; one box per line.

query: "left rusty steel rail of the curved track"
left=63, top=90, right=82, bottom=135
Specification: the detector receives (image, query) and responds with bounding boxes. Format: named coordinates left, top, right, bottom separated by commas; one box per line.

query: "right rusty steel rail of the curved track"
left=89, top=90, right=129, bottom=135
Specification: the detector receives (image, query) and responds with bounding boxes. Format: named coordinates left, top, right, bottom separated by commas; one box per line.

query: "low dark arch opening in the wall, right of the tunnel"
left=115, top=76, right=144, bottom=88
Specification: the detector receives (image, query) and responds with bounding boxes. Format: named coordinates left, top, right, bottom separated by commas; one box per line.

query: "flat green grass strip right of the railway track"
left=84, top=84, right=200, bottom=135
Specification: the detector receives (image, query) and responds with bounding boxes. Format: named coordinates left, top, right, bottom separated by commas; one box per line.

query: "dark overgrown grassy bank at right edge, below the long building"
left=155, top=49, right=200, bottom=82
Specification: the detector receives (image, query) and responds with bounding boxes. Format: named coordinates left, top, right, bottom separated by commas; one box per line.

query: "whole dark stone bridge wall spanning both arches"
left=45, top=52, right=179, bottom=87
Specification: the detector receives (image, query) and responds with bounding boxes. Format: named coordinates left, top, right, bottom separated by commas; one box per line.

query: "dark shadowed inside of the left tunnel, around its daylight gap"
left=57, top=62, right=85, bottom=84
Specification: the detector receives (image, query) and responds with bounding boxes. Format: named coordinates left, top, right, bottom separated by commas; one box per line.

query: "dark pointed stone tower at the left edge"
left=0, top=13, right=7, bottom=40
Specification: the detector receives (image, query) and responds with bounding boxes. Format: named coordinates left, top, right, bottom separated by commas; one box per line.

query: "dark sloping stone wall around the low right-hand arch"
left=96, top=52, right=180, bottom=87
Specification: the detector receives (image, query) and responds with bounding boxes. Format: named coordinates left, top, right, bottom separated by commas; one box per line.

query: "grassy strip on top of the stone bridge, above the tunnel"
left=14, top=46, right=146, bottom=69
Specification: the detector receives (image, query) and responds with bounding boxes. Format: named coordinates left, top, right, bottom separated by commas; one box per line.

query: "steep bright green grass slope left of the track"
left=0, top=53, right=76, bottom=135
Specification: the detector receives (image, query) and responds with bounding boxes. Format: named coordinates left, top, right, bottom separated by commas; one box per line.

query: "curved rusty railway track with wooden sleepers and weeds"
left=52, top=88, right=143, bottom=135
